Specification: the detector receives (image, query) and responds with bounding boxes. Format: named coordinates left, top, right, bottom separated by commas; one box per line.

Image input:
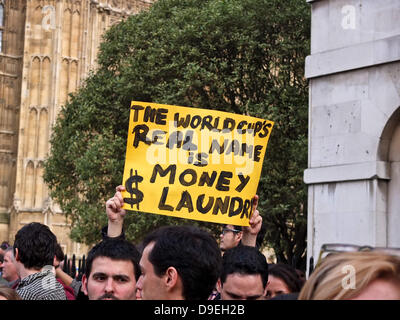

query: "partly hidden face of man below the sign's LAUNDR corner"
left=218, top=273, right=265, bottom=300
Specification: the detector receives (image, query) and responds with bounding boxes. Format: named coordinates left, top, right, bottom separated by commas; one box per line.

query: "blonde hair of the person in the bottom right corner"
left=298, top=251, right=400, bottom=300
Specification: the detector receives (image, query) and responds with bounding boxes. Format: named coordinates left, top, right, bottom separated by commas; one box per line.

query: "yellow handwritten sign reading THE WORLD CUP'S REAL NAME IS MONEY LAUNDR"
left=123, top=101, right=274, bottom=226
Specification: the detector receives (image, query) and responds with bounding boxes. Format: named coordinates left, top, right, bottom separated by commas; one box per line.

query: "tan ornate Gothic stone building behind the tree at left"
left=0, top=0, right=154, bottom=255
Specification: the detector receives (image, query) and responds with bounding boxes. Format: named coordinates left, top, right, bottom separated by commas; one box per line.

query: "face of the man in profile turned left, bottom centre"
left=136, top=242, right=166, bottom=300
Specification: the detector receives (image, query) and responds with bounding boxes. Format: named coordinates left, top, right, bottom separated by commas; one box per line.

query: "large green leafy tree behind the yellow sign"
left=44, top=0, right=310, bottom=265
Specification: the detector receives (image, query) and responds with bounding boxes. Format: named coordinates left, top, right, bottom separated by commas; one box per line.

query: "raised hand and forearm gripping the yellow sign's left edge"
left=106, top=185, right=126, bottom=238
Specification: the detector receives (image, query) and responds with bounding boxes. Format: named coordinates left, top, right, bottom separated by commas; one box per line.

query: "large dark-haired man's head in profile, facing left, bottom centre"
left=136, top=226, right=221, bottom=300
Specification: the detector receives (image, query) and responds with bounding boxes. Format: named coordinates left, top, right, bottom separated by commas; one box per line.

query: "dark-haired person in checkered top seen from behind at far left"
left=14, top=222, right=66, bottom=300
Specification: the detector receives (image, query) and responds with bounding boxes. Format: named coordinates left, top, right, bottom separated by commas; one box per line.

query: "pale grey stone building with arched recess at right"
left=304, top=0, right=400, bottom=268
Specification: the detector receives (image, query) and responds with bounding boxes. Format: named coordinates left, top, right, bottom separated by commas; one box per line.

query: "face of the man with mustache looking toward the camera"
left=82, top=257, right=136, bottom=300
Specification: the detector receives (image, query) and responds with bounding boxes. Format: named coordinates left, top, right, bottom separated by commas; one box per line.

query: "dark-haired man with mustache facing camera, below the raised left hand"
left=82, top=239, right=140, bottom=300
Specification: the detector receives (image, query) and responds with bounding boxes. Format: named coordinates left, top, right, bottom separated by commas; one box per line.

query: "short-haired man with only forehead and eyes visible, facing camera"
left=217, top=246, right=268, bottom=300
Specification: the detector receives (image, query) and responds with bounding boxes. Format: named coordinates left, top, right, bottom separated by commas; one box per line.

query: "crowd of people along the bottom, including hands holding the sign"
left=0, top=186, right=400, bottom=300
